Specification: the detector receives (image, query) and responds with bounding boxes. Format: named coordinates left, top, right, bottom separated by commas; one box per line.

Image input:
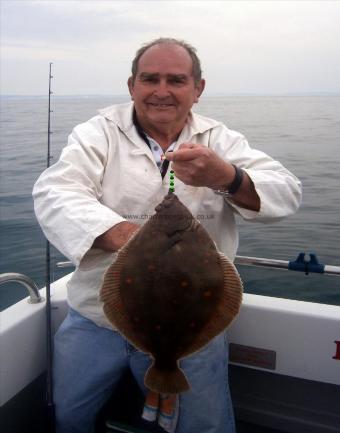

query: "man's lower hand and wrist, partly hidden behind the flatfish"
left=93, top=221, right=140, bottom=251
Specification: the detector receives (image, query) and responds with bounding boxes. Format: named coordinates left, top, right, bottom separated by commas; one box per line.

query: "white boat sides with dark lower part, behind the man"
left=0, top=275, right=340, bottom=433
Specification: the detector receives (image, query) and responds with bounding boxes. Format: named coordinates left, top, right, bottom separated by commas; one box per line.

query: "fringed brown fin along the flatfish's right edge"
left=181, top=252, right=243, bottom=358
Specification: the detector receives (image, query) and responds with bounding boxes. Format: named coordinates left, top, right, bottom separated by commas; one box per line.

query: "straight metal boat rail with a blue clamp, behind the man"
left=57, top=253, right=340, bottom=276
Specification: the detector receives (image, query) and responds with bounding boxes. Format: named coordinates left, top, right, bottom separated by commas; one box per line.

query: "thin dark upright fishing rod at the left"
left=46, top=63, right=54, bottom=433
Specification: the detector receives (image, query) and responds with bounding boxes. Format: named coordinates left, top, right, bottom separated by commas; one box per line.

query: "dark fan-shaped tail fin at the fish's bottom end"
left=144, top=363, right=190, bottom=394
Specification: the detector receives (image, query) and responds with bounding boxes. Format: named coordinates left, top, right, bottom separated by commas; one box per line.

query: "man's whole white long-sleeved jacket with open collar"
left=33, top=103, right=301, bottom=328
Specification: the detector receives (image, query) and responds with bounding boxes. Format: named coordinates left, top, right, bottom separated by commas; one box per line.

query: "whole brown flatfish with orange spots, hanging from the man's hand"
left=101, top=192, right=242, bottom=393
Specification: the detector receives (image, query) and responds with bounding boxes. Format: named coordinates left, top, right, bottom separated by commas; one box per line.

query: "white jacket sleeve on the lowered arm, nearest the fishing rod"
left=33, top=116, right=125, bottom=266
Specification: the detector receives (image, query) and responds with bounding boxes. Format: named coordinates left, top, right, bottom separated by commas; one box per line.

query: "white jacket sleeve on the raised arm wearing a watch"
left=214, top=127, right=302, bottom=222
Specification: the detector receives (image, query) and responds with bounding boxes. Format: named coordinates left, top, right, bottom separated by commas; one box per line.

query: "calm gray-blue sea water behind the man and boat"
left=0, top=96, right=340, bottom=309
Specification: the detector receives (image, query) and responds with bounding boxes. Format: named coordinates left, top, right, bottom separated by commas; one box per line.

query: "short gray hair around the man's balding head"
left=131, top=38, right=202, bottom=84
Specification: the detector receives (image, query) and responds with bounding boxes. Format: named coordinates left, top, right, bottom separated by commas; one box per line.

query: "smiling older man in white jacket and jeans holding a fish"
left=33, top=38, right=301, bottom=433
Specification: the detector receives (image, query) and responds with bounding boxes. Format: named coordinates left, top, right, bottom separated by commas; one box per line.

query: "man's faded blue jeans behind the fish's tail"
left=53, top=310, right=235, bottom=433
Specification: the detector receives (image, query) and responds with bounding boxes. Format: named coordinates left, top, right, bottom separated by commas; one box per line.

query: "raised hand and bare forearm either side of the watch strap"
left=165, top=143, right=261, bottom=212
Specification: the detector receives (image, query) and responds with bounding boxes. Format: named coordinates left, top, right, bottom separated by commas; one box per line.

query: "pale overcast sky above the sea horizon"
left=0, top=0, right=340, bottom=95
